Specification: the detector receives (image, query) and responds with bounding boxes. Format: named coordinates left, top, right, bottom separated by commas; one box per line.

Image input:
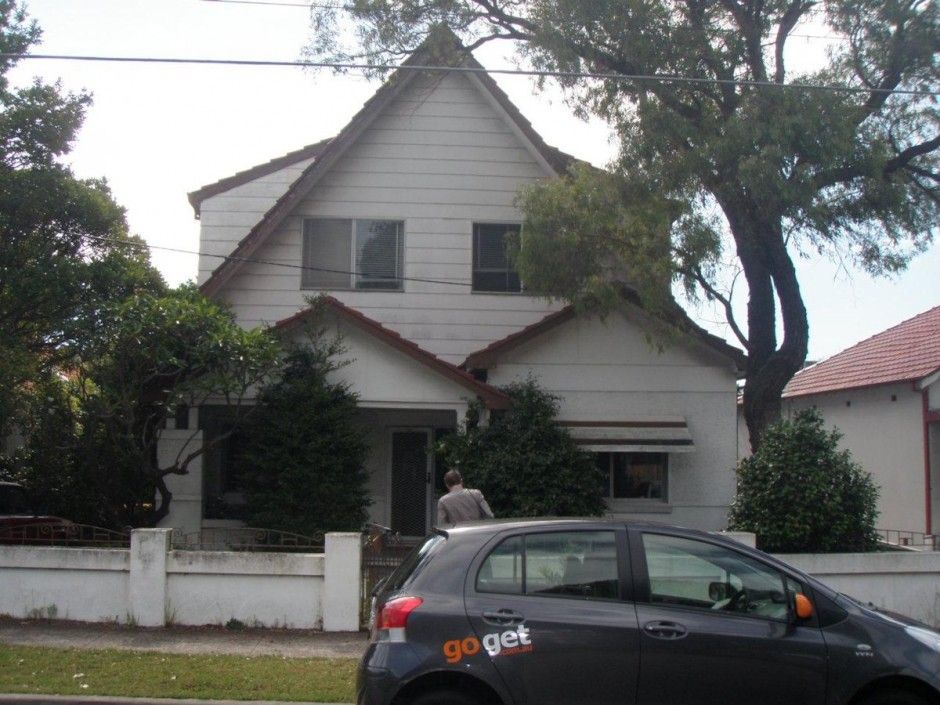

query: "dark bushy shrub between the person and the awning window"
left=439, top=379, right=606, bottom=517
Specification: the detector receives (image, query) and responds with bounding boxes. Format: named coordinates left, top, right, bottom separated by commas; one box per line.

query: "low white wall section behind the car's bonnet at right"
left=776, top=551, right=940, bottom=627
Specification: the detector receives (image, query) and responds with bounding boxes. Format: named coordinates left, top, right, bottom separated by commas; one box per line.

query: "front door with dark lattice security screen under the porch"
left=390, top=430, right=431, bottom=536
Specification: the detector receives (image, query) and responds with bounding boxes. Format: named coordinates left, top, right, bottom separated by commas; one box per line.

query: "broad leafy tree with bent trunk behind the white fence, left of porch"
left=4, top=286, right=279, bottom=527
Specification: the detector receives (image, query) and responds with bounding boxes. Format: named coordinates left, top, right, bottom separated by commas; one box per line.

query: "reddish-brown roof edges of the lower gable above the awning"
left=460, top=291, right=747, bottom=373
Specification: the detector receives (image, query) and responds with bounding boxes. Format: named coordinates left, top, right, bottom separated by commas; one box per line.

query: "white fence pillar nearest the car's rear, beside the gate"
left=323, top=532, right=362, bottom=632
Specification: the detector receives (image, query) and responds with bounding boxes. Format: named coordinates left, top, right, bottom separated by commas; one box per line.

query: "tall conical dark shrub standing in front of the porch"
left=238, top=332, right=369, bottom=535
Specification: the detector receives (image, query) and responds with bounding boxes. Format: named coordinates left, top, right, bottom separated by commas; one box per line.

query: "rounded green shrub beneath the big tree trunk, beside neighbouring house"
left=730, top=408, right=878, bottom=553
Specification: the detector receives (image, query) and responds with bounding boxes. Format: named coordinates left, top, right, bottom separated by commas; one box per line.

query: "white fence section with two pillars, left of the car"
left=0, top=529, right=361, bottom=631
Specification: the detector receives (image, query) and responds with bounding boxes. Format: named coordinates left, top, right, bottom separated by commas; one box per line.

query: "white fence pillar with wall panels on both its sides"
left=128, top=529, right=173, bottom=627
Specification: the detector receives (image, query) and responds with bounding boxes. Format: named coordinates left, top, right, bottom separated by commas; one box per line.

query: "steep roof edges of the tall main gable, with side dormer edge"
left=199, top=27, right=577, bottom=296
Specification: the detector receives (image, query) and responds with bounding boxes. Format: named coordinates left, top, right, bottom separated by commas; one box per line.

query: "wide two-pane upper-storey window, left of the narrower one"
left=300, top=218, right=405, bottom=291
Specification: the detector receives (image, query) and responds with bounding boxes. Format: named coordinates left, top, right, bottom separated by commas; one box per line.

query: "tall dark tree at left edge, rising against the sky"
left=0, top=0, right=163, bottom=436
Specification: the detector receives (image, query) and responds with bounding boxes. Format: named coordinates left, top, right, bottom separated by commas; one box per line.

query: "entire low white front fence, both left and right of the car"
left=0, top=529, right=940, bottom=631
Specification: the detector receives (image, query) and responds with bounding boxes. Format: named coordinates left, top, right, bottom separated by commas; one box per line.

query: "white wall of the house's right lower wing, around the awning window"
left=489, top=313, right=736, bottom=530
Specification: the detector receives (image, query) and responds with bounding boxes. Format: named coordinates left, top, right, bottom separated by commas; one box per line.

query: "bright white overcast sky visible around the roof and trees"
left=13, top=0, right=940, bottom=359
